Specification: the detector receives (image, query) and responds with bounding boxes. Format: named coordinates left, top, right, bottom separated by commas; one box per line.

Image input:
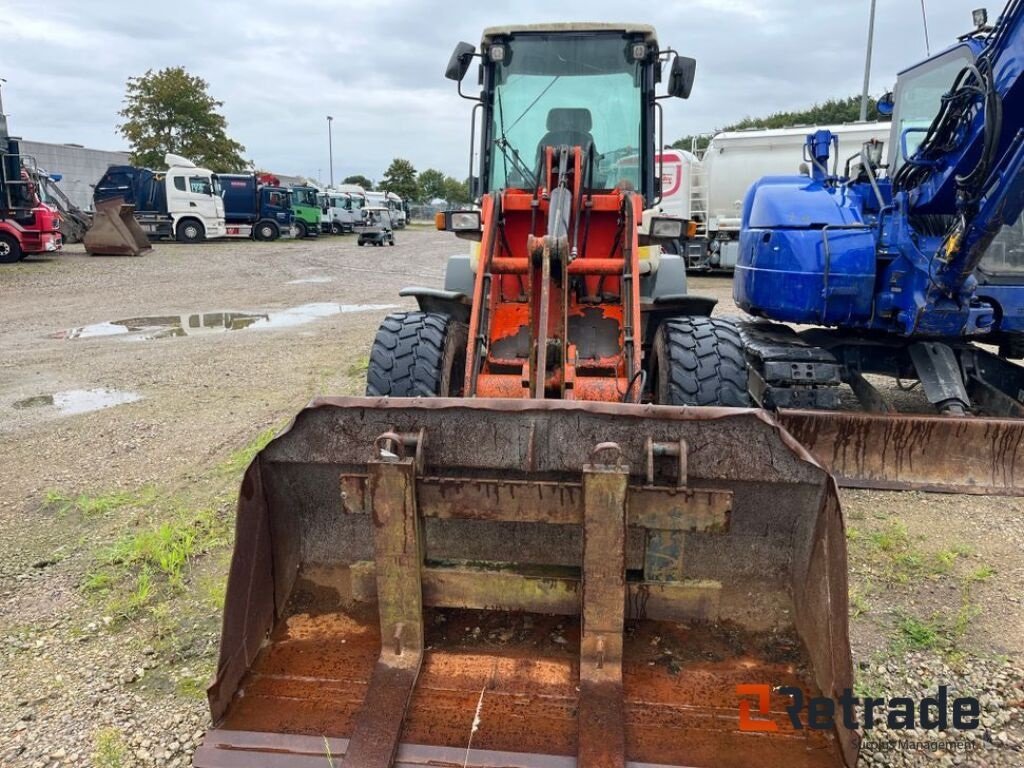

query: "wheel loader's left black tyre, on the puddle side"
left=367, top=312, right=467, bottom=397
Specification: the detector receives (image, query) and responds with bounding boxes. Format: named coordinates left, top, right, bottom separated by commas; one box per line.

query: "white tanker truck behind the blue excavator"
left=675, top=122, right=891, bottom=271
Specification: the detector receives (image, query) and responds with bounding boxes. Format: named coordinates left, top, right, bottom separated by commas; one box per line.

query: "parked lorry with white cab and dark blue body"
left=93, top=153, right=226, bottom=243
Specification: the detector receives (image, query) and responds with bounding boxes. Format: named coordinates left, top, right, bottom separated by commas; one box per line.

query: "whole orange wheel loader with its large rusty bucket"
left=195, top=25, right=858, bottom=768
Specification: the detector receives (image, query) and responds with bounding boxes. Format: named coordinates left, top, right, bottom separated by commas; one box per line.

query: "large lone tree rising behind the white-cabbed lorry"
left=118, top=67, right=247, bottom=173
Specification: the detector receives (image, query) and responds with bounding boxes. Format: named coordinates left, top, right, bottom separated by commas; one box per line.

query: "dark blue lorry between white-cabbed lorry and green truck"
left=219, top=173, right=295, bottom=240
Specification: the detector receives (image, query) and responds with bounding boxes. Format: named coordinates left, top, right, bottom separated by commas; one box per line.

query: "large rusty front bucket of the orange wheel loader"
left=194, top=398, right=858, bottom=768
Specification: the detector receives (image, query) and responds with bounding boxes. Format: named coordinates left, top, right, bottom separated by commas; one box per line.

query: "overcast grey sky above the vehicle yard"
left=0, top=0, right=987, bottom=181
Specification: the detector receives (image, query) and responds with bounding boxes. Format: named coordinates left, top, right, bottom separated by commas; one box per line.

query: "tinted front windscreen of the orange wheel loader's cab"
left=489, top=34, right=642, bottom=189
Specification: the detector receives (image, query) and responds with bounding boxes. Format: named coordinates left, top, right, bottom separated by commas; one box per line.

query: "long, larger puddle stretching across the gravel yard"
left=51, top=302, right=396, bottom=341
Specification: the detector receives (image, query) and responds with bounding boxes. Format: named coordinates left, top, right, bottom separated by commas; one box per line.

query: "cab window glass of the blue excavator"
left=889, top=46, right=973, bottom=175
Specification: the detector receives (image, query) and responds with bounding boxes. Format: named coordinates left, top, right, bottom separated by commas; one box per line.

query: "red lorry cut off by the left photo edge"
left=0, top=91, right=62, bottom=264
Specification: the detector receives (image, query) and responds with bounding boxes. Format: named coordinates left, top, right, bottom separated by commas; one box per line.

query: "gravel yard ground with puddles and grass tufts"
left=0, top=230, right=1024, bottom=768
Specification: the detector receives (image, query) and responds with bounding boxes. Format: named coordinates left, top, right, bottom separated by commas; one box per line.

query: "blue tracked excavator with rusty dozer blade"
left=660, top=0, right=1024, bottom=495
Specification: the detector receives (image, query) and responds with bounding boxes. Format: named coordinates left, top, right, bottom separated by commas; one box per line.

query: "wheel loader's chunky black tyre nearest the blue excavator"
left=653, top=317, right=751, bottom=408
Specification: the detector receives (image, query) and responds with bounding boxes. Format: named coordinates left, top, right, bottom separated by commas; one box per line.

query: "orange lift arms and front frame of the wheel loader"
left=465, top=146, right=643, bottom=402
